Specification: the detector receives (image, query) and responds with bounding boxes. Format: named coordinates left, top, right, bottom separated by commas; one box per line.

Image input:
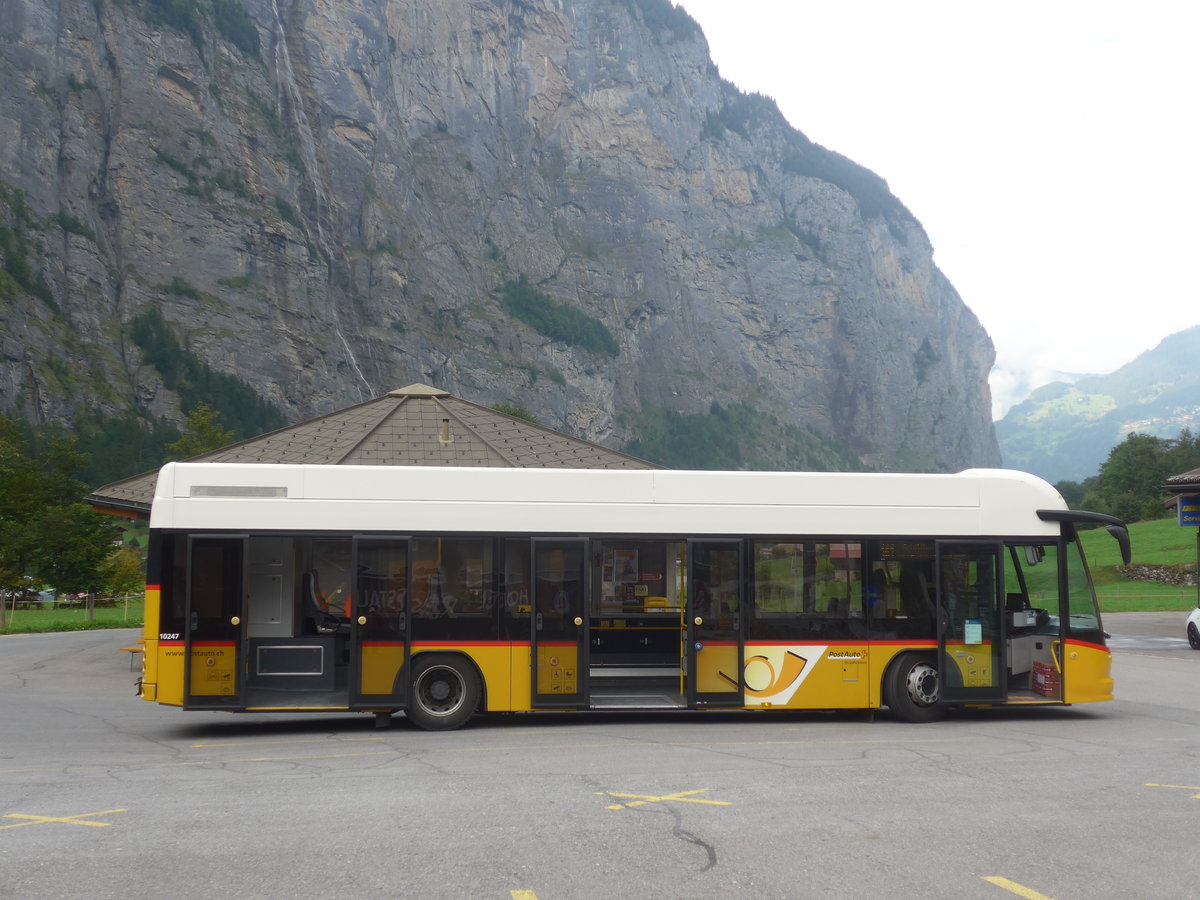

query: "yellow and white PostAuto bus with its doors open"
left=140, top=463, right=1128, bottom=728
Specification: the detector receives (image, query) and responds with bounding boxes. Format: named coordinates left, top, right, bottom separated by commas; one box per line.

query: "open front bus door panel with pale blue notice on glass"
left=936, top=541, right=1007, bottom=703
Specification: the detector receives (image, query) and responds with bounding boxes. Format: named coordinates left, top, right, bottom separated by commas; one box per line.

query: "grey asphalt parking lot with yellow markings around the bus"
left=0, top=613, right=1200, bottom=900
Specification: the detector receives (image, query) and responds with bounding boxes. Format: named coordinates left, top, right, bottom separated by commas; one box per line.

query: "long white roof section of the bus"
left=150, top=463, right=1067, bottom=536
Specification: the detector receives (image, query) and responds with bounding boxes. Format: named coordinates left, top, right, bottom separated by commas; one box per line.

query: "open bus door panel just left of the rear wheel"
left=349, top=538, right=413, bottom=709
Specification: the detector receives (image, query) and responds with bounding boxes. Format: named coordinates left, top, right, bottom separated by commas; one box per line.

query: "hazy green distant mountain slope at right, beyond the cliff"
left=996, top=325, right=1200, bottom=481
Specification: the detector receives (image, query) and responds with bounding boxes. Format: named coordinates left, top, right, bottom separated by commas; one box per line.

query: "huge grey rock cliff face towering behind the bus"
left=0, top=0, right=1000, bottom=469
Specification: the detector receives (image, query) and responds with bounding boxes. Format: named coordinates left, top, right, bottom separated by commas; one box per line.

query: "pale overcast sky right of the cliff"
left=677, top=0, right=1200, bottom=415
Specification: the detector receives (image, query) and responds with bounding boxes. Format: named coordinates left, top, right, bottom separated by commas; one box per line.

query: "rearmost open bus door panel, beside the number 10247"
left=184, top=534, right=248, bottom=709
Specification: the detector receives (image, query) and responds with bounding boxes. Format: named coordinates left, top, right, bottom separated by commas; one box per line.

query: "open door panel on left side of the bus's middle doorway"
left=530, top=538, right=588, bottom=708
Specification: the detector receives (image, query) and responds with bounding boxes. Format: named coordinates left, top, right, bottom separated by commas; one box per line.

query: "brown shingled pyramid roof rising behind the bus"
left=85, top=384, right=661, bottom=517
